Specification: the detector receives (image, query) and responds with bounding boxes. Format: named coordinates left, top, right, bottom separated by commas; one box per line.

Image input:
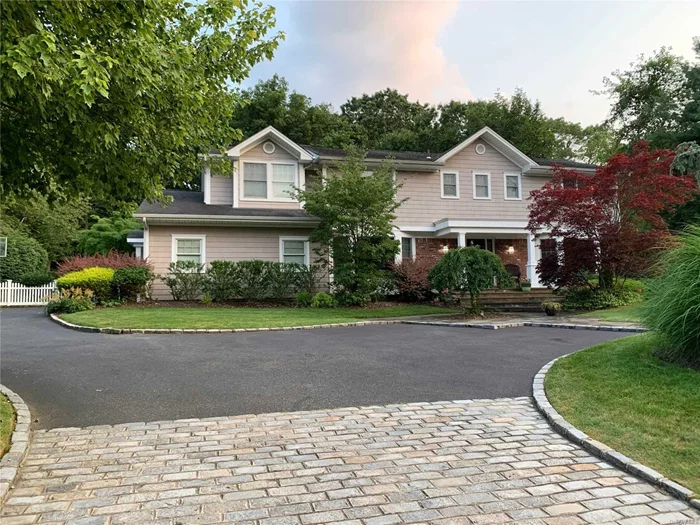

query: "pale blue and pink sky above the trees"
left=244, top=0, right=700, bottom=125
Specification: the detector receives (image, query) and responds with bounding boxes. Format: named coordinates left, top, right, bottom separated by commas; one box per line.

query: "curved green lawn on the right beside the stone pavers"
left=545, top=334, right=700, bottom=493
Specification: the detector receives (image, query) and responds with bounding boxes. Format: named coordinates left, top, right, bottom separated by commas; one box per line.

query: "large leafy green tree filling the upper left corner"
left=0, top=0, right=283, bottom=205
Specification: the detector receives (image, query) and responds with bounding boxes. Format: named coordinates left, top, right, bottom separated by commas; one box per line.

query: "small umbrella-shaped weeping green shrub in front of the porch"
left=429, top=246, right=511, bottom=312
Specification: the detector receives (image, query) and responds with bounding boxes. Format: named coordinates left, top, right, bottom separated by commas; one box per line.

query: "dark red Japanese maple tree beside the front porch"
left=528, top=142, right=698, bottom=288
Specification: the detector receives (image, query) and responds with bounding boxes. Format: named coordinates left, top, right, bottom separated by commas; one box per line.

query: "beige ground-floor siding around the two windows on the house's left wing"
left=148, top=226, right=314, bottom=300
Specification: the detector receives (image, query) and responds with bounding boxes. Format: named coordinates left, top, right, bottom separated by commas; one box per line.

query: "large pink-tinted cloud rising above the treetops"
left=273, top=1, right=472, bottom=104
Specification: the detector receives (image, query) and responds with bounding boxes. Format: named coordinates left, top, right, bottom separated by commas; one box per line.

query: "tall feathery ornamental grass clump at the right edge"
left=642, top=226, right=700, bottom=368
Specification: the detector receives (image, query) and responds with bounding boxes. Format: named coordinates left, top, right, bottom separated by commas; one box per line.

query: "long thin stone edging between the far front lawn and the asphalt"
left=50, top=314, right=647, bottom=334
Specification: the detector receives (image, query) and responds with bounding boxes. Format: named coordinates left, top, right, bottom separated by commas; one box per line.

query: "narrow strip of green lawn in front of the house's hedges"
left=61, top=305, right=456, bottom=329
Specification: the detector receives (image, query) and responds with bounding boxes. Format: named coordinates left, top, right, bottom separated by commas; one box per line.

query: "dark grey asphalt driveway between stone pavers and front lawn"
left=0, top=308, right=628, bottom=428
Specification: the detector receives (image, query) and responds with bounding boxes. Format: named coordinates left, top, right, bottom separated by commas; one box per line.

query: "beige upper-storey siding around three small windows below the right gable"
left=396, top=137, right=548, bottom=227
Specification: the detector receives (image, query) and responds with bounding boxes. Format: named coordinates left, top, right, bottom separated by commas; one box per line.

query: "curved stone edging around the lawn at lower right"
left=532, top=352, right=700, bottom=509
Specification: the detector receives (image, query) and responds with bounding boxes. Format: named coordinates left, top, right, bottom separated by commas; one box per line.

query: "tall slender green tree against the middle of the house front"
left=297, top=148, right=402, bottom=304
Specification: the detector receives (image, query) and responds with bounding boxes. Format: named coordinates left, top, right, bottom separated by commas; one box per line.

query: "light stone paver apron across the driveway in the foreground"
left=0, top=398, right=700, bottom=525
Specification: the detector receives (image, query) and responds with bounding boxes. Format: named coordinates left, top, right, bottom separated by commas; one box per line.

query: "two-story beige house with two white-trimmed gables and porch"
left=129, top=127, right=595, bottom=299
